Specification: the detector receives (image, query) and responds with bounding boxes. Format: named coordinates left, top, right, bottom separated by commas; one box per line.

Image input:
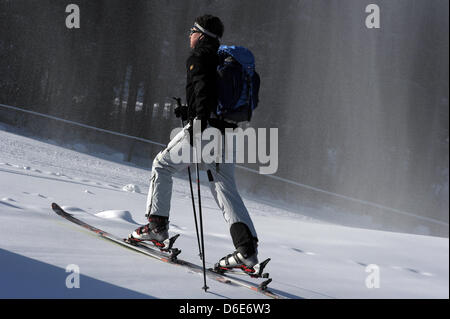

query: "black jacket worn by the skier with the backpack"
left=186, top=37, right=219, bottom=124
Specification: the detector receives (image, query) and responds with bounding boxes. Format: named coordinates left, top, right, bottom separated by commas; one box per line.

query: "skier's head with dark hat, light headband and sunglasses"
left=189, top=14, right=224, bottom=49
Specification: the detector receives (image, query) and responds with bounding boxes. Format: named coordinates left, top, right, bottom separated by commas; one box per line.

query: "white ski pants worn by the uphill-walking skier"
left=146, top=124, right=257, bottom=237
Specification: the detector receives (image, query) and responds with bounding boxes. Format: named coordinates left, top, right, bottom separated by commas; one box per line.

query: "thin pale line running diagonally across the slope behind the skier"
left=0, top=104, right=449, bottom=227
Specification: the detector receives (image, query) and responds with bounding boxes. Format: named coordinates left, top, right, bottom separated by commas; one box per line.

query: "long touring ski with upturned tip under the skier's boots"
left=52, top=203, right=285, bottom=299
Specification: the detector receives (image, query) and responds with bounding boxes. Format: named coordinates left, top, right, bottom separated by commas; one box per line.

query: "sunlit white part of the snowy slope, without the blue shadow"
left=0, top=130, right=448, bottom=298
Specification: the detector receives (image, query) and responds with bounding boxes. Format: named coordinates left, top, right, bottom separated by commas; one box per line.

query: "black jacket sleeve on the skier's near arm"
left=187, top=55, right=216, bottom=124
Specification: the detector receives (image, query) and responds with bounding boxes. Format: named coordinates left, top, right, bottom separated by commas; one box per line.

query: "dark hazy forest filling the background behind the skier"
left=0, top=0, right=449, bottom=236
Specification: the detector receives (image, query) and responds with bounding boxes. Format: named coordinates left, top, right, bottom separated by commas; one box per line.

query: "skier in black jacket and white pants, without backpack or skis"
left=128, top=15, right=258, bottom=268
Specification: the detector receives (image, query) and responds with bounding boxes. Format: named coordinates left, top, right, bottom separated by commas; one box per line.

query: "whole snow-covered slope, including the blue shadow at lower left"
left=0, top=127, right=449, bottom=299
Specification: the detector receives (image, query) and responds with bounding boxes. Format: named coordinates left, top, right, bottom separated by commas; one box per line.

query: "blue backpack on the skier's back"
left=216, top=45, right=260, bottom=123
